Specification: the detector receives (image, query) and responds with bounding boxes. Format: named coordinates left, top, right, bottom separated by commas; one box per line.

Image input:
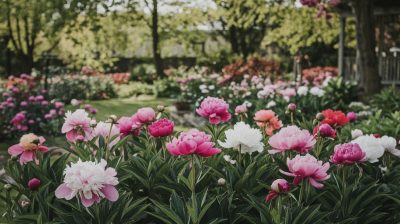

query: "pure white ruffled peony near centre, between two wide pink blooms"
left=218, top=122, right=264, bottom=154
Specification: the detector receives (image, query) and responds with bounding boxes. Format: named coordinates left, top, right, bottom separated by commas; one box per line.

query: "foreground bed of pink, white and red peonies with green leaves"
left=0, top=97, right=400, bottom=223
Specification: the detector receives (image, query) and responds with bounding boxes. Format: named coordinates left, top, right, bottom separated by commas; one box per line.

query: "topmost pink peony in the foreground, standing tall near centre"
left=196, top=97, right=231, bottom=124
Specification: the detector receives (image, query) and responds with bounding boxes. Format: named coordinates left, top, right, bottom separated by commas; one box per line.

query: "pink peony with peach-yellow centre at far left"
left=8, top=133, right=49, bottom=165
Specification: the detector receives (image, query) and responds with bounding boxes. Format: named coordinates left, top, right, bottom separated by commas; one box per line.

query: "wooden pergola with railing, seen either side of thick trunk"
left=338, top=0, right=400, bottom=85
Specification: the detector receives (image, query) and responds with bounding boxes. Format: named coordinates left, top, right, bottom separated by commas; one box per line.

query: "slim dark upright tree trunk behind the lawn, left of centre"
left=151, top=0, right=165, bottom=78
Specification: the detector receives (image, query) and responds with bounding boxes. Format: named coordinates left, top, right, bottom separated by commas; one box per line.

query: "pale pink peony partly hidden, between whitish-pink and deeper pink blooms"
left=92, top=121, right=120, bottom=149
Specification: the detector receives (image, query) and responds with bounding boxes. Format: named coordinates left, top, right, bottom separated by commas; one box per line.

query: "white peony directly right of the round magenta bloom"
left=351, top=135, right=385, bottom=163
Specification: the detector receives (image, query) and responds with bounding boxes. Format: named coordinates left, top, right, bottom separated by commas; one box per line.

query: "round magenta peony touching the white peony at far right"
left=330, top=143, right=366, bottom=165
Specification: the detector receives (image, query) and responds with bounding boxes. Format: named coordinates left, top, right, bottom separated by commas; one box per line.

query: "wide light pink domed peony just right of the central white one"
left=268, top=126, right=316, bottom=154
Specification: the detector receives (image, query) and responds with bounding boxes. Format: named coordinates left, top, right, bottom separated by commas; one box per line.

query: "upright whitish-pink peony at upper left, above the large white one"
left=61, top=109, right=92, bottom=142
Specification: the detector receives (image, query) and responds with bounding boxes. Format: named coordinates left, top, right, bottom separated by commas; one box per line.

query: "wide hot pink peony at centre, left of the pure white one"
left=167, top=129, right=221, bottom=157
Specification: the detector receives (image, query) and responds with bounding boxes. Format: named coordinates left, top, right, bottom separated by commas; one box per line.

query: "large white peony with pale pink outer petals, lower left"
left=55, top=160, right=119, bottom=207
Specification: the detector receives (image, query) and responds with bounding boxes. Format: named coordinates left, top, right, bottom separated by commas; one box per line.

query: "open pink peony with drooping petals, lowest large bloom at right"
left=280, top=154, right=330, bottom=188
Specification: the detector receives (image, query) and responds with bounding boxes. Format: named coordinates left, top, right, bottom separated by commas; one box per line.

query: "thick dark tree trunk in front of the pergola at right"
left=353, top=0, right=381, bottom=97
